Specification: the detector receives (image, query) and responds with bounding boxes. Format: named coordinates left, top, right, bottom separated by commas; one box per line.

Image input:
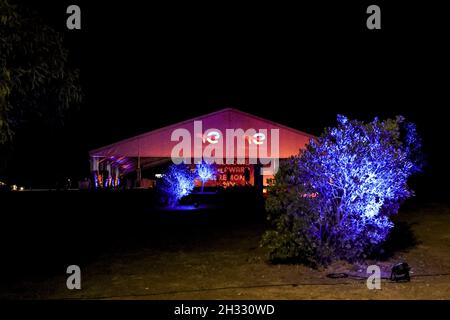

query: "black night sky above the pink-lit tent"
left=4, top=0, right=450, bottom=199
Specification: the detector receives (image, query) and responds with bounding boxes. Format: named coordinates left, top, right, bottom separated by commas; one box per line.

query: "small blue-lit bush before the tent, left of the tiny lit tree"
left=161, top=163, right=195, bottom=207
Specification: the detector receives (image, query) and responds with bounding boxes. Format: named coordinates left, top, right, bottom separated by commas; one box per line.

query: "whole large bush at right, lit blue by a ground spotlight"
left=262, top=116, right=422, bottom=265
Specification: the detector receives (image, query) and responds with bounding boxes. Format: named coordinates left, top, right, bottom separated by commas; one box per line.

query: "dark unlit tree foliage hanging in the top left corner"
left=0, top=0, right=82, bottom=145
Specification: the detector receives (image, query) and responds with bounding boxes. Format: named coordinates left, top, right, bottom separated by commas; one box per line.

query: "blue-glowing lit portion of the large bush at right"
left=286, top=116, right=422, bottom=259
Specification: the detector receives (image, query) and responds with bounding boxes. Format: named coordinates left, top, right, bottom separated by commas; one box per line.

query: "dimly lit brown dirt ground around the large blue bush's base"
left=2, top=205, right=450, bottom=299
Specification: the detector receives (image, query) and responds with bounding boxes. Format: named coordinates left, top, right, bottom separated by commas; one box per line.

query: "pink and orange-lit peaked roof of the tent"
left=89, top=108, right=315, bottom=158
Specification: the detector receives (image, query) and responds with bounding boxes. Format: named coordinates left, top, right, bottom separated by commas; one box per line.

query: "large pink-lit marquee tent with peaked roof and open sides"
left=89, top=108, right=315, bottom=185
